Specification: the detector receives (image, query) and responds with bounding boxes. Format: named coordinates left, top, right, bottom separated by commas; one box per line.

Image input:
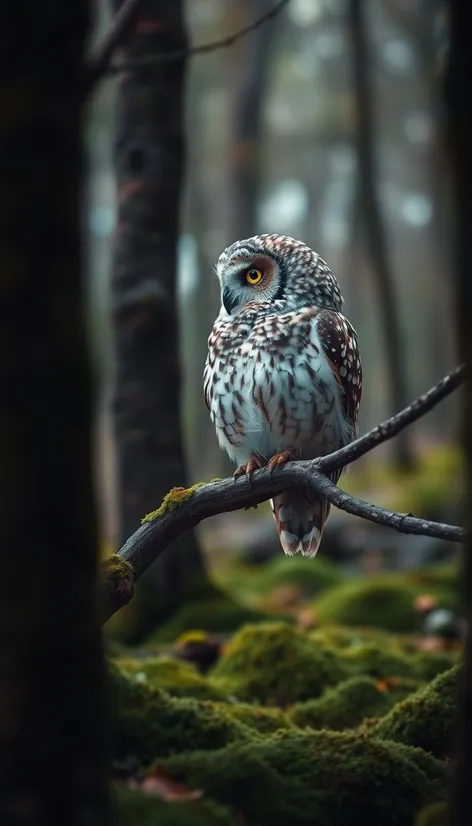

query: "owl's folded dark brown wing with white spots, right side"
left=316, top=310, right=362, bottom=431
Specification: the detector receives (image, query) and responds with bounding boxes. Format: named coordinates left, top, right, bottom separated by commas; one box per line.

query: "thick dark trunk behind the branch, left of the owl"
left=112, top=0, right=214, bottom=641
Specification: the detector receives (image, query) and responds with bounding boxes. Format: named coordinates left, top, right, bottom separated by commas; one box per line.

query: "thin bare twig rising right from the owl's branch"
left=317, top=364, right=466, bottom=473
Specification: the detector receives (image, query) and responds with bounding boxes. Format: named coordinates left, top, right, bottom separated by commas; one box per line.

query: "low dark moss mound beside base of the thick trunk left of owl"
left=148, top=597, right=267, bottom=644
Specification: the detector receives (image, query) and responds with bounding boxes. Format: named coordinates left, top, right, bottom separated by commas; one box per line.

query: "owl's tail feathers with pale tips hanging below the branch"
left=271, top=491, right=330, bottom=557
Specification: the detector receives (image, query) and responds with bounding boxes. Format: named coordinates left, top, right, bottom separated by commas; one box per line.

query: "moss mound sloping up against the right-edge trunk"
left=370, top=665, right=461, bottom=757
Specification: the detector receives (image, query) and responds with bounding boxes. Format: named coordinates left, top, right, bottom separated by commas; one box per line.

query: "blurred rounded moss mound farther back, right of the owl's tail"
left=313, top=573, right=457, bottom=633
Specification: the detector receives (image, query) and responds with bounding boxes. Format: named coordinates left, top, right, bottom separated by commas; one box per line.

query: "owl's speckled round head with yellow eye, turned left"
left=216, top=235, right=343, bottom=315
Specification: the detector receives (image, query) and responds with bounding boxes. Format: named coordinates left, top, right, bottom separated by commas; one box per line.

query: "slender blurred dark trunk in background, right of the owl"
left=349, top=0, right=414, bottom=470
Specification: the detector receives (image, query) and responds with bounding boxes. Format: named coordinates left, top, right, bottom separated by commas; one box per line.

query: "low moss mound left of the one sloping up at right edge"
left=290, top=676, right=392, bottom=731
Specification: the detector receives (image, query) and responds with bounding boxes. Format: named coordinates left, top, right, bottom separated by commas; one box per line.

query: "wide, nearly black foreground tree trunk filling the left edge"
left=0, top=0, right=108, bottom=826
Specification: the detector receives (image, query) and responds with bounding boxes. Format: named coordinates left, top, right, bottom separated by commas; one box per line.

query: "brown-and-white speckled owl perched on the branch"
left=203, top=234, right=362, bottom=557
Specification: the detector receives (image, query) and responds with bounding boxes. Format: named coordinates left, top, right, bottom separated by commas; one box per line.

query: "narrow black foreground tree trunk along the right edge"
left=446, top=0, right=472, bottom=826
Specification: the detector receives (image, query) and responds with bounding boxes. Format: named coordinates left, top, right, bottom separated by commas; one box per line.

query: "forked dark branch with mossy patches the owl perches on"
left=102, top=366, right=466, bottom=621
